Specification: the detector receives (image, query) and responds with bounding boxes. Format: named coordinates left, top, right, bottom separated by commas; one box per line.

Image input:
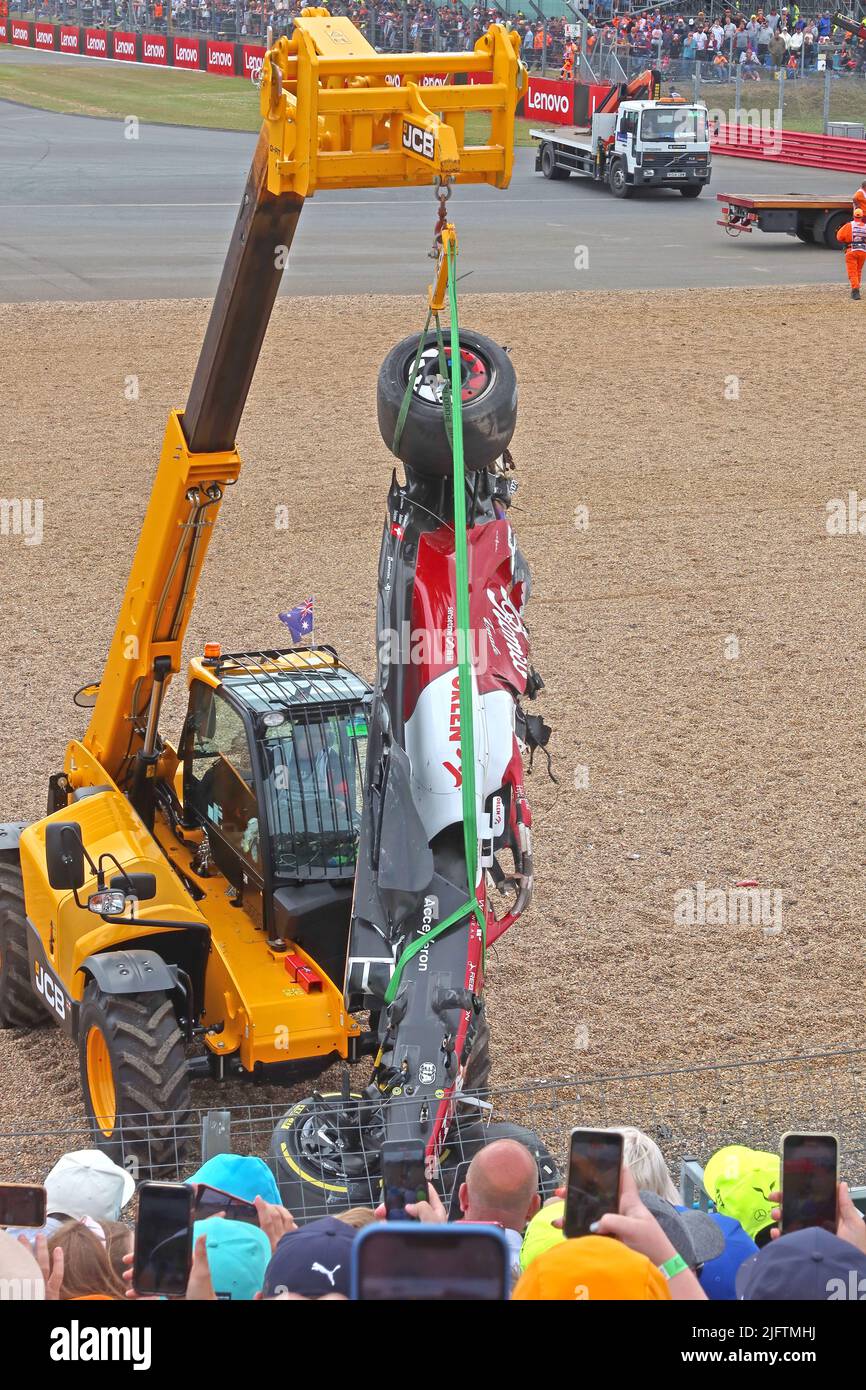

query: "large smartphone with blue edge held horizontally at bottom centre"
left=352, top=1220, right=512, bottom=1302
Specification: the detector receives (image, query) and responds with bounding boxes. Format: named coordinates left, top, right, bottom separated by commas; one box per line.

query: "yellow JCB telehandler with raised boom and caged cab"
left=0, top=10, right=556, bottom=1206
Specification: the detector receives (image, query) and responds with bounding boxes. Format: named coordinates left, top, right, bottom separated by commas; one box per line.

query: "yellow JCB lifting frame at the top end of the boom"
left=261, top=10, right=527, bottom=197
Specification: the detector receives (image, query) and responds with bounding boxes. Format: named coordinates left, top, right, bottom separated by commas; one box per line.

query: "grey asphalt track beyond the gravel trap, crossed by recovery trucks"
left=0, top=75, right=859, bottom=303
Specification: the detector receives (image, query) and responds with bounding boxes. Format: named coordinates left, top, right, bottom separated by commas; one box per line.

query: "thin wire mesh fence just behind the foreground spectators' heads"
left=0, top=1048, right=866, bottom=1219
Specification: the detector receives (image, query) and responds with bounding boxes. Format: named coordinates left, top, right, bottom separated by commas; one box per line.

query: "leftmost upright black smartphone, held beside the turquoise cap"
left=132, top=1183, right=195, bottom=1298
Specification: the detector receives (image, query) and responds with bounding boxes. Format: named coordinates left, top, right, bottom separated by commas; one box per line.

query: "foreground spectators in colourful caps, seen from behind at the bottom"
left=0, top=1127, right=866, bottom=1302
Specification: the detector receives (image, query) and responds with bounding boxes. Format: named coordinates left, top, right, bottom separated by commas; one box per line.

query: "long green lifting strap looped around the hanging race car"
left=385, top=246, right=487, bottom=1004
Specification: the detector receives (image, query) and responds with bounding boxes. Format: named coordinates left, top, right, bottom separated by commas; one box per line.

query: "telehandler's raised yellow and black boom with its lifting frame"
left=77, top=10, right=527, bottom=823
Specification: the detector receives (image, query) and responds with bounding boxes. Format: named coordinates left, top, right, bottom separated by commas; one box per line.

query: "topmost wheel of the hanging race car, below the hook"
left=377, top=328, right=517, bottom=478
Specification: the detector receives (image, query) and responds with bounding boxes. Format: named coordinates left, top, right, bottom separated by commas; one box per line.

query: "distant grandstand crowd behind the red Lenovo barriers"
left=13, top=0, right=866, bottom=79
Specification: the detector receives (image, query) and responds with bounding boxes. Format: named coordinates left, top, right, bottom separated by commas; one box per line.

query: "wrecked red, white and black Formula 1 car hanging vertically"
left=272, top=329, right=557, bottom=1212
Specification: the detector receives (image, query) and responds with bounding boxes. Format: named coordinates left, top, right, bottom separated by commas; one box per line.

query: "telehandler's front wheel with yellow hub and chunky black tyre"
left=78, top=980, right=189, bottom=1179
